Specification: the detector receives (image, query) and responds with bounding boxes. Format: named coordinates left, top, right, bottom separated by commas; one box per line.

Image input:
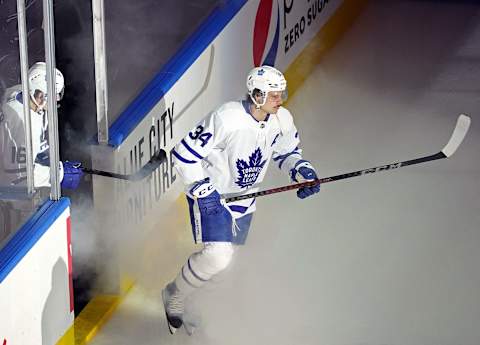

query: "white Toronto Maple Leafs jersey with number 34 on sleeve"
left=173, top=101, right=302, bottom=218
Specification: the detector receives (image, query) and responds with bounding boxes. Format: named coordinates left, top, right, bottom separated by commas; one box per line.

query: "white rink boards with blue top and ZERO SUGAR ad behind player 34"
left=93, top=0, right=352, bottom=234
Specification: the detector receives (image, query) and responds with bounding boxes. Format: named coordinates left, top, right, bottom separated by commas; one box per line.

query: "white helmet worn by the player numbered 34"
left=247, top=66, right=288, bottom=107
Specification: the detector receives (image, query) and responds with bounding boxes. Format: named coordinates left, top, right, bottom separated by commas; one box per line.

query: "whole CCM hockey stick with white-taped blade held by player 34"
left=225, top=114, right=471, bottom=202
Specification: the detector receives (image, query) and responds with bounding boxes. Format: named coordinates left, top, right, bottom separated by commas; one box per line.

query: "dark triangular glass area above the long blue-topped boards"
left=105, top=0, right=222, bottom=125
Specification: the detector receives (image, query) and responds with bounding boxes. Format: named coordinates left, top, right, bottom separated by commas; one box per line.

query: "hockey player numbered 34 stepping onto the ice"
left=162, top=66, right=320, bottom=334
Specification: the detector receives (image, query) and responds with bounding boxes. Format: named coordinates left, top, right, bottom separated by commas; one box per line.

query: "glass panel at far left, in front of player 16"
left=0, top=0, right=49, bottom=248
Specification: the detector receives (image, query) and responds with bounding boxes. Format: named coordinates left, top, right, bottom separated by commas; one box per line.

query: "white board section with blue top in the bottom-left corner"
left=0, top=198, right=74, bottom=345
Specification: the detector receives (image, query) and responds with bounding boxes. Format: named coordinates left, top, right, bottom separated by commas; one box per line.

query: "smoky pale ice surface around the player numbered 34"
left=63, top=1, right=480, bottom=345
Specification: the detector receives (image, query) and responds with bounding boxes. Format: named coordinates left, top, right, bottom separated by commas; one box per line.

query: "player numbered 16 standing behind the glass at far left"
left=0, top=62, right=83, bottom=237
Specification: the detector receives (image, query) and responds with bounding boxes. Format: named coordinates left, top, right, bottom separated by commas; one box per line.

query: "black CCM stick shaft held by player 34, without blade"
left=225, top=152, right=447, bottom=202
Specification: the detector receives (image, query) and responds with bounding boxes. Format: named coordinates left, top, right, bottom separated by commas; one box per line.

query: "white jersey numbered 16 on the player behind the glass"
left=0, top=89, right=63, bottom=187
